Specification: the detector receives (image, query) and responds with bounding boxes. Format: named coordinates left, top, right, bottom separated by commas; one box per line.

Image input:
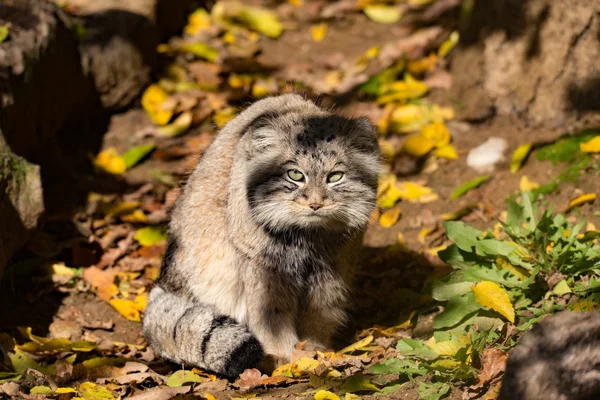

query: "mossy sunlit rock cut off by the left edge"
left=0, top=132, right=44, bottom=278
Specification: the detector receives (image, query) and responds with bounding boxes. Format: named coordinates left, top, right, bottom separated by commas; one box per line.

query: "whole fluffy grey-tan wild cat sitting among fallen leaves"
left=144, top=95, right=379, bottom=377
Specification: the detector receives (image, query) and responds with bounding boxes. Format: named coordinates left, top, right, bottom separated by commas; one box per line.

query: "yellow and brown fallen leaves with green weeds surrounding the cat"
left=0, top=0, right=600, bottom=400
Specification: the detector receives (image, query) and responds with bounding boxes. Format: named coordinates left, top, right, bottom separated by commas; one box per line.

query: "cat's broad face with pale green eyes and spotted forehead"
left=247, top=113, right=380, bottom=231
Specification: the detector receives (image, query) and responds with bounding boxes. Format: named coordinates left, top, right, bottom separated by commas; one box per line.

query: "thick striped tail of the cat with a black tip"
left=143, top=286, right=264, bottom=379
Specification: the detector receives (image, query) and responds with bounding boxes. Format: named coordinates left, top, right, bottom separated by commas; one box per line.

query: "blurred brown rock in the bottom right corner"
left=498, top=311, right=600, bottom=400
